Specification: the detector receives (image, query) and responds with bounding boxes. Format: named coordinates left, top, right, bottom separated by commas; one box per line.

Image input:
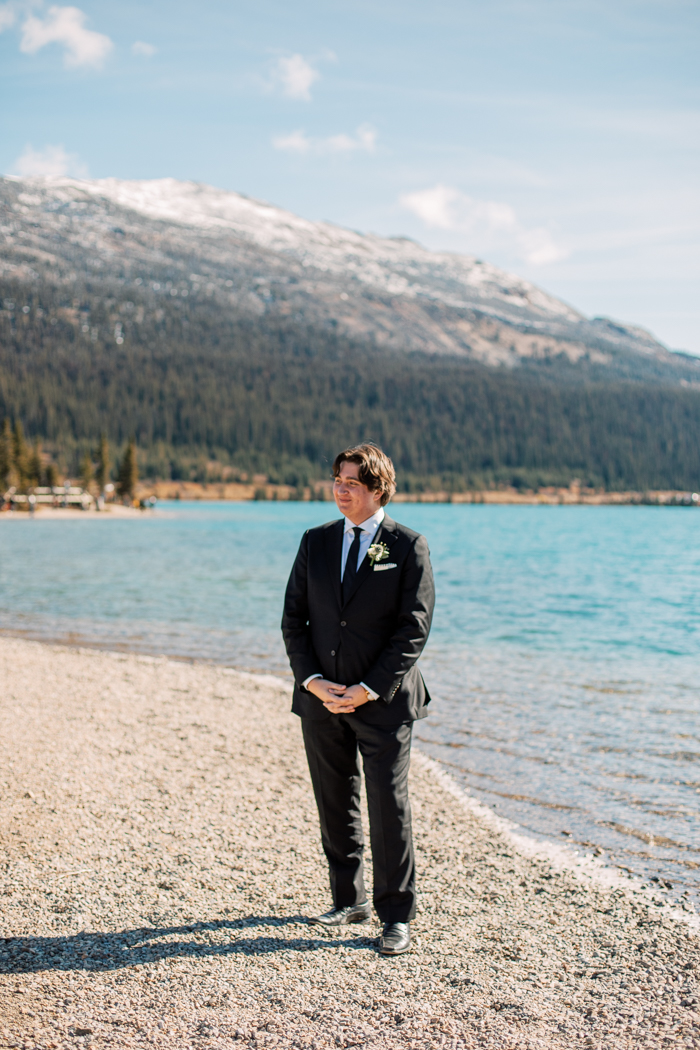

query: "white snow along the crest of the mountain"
left=12, top=175, right=585, bottom=323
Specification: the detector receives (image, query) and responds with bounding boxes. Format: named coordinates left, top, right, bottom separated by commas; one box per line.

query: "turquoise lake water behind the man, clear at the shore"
left=0, top=502, right=700, bottom=897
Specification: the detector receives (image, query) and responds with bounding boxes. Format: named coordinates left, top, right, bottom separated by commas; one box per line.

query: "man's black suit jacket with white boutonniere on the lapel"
left=282, top=517, right=434, bottom=726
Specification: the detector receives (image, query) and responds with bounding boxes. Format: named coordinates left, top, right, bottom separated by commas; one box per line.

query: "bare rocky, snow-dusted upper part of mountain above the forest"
left=0, top=176, right=688, bottom=375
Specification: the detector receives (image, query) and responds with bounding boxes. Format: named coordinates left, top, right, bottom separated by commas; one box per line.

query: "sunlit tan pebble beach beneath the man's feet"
left=0, top=637, right=700, bottom=1050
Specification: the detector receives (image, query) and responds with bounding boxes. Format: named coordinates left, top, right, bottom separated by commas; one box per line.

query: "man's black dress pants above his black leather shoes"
left=301, top=715, right=416, bottom=922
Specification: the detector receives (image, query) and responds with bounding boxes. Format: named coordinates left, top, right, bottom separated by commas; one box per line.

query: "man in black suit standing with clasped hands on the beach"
left=282, top=444, right=434, bottom=956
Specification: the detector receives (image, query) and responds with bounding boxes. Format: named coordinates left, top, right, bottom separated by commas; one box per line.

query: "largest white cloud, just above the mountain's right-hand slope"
left=399, top=183, right=567, bottom=266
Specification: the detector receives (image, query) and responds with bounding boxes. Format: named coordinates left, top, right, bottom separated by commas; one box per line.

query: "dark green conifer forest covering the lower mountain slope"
left=0, top=277, right=700, bottom=490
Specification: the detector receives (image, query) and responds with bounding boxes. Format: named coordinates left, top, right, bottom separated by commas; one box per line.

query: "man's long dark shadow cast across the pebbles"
left=0, top=916, right=384, bottom=973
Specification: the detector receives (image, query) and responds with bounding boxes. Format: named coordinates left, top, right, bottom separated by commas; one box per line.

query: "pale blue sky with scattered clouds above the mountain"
left=0, top=0, right=700, bottom=354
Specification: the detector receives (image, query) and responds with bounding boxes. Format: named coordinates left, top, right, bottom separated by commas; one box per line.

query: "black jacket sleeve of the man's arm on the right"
left=363, top=536, right=436, bottom=704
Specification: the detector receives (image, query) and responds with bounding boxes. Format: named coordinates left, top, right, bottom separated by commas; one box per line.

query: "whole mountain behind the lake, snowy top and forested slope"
left=0, top=172, right=700, bottom=491
